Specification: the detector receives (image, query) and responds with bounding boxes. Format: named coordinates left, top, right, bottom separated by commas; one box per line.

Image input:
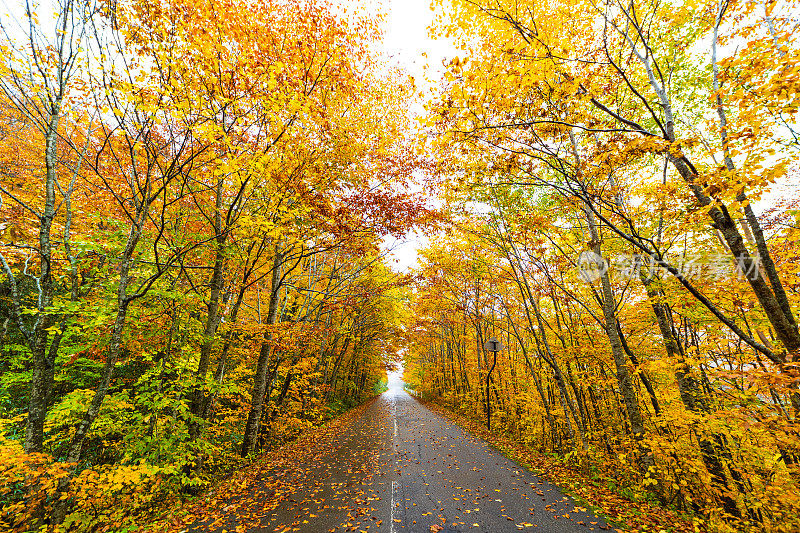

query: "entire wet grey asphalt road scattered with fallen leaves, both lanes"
left=190, top=378, right=607, bottom=533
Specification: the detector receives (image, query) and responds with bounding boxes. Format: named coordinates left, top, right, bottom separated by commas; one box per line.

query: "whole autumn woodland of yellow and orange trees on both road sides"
left=0, top=0, right=800, bottom=532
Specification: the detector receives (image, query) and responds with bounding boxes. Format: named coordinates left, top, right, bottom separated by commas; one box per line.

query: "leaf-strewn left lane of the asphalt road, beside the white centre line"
left=151, top=399, right=385, bottom=532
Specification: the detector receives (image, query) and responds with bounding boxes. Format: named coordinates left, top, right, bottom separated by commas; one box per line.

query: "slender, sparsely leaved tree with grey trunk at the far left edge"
left=0, top=1, right=96, bottom=452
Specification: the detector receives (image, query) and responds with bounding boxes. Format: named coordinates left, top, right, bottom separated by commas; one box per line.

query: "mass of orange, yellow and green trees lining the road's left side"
left=0, top=1, right=432, bottom=530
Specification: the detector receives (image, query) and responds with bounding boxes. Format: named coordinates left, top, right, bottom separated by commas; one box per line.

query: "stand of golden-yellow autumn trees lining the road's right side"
left=411, top=1, right=797, bottom=528
